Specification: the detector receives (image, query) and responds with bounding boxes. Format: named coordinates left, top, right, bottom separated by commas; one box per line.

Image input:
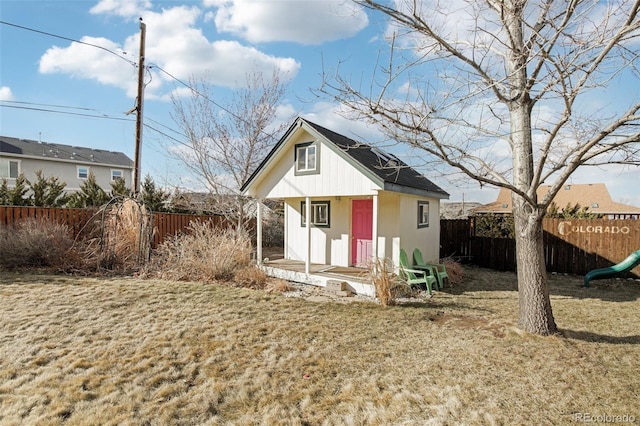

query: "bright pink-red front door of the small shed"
left=351, top=200, right=373, bottom=266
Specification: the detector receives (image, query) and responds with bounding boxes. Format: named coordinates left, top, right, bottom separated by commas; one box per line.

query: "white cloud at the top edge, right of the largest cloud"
left=208, top=0, right=369, bottom=44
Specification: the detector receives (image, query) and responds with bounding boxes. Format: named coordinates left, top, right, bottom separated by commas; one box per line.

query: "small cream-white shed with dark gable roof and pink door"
left=241, top=118, right=449, bottom=274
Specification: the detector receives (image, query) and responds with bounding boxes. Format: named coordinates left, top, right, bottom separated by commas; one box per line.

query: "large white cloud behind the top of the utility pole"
left=40, top=4, right=300, bottom=99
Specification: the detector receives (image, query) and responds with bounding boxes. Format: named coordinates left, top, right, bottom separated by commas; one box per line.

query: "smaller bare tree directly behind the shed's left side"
left=172, top=71, right=293, bottom=227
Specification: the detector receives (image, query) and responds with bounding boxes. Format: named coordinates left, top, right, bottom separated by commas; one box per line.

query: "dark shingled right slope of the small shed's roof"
left=303, top=119, right=449, bottom=196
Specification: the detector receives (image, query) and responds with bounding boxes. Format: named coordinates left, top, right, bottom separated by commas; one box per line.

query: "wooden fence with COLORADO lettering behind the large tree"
left=440, top=218, right=640, bottom=276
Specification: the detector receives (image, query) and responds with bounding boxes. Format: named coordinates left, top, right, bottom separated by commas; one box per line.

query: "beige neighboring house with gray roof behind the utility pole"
left=0, top=136, right=133, bottom=192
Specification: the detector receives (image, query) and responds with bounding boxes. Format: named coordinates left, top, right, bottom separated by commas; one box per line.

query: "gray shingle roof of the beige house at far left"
left=0, top=136, right=133, bottom=168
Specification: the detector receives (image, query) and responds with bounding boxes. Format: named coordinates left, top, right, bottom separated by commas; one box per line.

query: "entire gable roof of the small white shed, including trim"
left=241, top=117, right=449, bottom=198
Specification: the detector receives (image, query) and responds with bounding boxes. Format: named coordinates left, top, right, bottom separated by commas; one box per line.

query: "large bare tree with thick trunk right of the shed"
left=320, top=0, right=640, bottom=335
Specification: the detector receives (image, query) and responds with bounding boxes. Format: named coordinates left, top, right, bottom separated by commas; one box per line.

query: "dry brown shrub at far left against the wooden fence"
left=0, top=219, right=76, bottom=270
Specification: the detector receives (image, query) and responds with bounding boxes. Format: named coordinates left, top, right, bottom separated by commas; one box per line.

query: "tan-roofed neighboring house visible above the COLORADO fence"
left=473, top=183, right=640, bottom=219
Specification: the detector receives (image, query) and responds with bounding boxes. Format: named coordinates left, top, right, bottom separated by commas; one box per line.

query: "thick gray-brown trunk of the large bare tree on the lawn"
left=513, top=194, right=558, bottom=336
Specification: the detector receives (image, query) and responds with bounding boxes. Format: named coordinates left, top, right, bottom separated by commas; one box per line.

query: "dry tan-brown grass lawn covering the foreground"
left=0, top=269, right=640, bottom=425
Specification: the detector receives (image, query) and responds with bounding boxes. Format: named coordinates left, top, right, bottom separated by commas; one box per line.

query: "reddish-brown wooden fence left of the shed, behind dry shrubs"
left=0, top=206, right=230, bottom=248
